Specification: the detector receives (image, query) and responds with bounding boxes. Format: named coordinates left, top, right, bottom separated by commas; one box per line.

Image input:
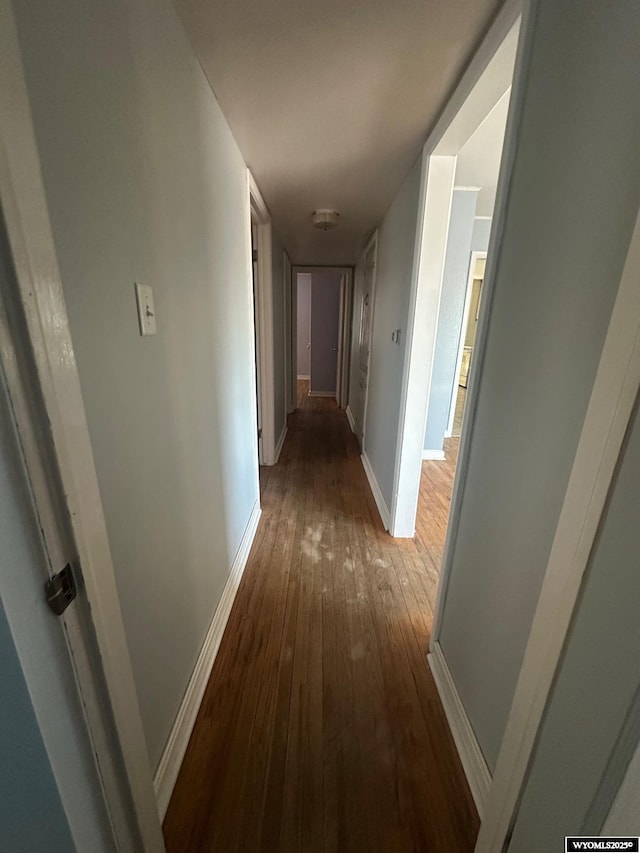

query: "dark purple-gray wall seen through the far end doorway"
left=310, top=272, right=342, bottom=394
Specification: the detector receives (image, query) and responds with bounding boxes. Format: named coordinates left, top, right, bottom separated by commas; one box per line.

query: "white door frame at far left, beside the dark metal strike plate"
left=0, top=5, right=164, bottom=853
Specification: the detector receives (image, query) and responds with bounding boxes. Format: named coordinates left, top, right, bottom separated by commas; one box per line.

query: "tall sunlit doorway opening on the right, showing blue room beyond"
left=391, top=9, right=520, bottom=572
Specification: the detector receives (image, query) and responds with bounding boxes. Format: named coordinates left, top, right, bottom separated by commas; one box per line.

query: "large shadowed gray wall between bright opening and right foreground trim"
left=439, top=0, right=640, bottom=772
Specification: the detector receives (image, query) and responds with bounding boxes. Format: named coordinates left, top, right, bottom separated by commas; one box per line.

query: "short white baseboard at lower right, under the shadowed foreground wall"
left=428, top=643, right=491, bottom=820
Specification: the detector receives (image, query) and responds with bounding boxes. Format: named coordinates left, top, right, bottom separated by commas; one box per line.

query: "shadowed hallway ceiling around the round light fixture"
left=176, top=0, right=500, bottom=264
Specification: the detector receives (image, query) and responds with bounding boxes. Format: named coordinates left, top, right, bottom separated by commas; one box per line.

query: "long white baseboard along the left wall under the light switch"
left=153, top=501, right=261, bottom=821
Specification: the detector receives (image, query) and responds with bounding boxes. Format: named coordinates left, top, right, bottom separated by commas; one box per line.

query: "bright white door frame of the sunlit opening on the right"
left=390, top=0, right=520, bottom=532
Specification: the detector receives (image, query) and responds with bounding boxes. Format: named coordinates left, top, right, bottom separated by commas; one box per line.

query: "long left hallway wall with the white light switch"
left=15, top=0, right=258, bottom=767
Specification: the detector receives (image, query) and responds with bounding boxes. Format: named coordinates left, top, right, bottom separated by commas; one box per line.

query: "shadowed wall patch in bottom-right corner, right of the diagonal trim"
left=509, top=404, right=640, bottom=853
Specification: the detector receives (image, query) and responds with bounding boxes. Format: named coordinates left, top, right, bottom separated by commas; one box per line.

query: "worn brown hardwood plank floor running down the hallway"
left=164, top=392, right=478, bottom=853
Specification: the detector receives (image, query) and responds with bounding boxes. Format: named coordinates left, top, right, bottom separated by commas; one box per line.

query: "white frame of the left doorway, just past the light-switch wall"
left=247, top=169, right=276, bottom=465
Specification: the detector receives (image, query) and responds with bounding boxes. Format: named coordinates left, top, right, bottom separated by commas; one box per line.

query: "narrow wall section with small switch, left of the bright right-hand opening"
left=360, top=158, right=422, bottom=508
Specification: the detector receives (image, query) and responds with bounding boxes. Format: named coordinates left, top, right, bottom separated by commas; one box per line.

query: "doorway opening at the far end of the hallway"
left=291, top=266, right=353, bottom=408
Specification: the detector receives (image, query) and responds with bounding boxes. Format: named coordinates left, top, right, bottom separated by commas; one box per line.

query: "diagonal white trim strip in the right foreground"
left=476, top=205, right=640, bottom=853
